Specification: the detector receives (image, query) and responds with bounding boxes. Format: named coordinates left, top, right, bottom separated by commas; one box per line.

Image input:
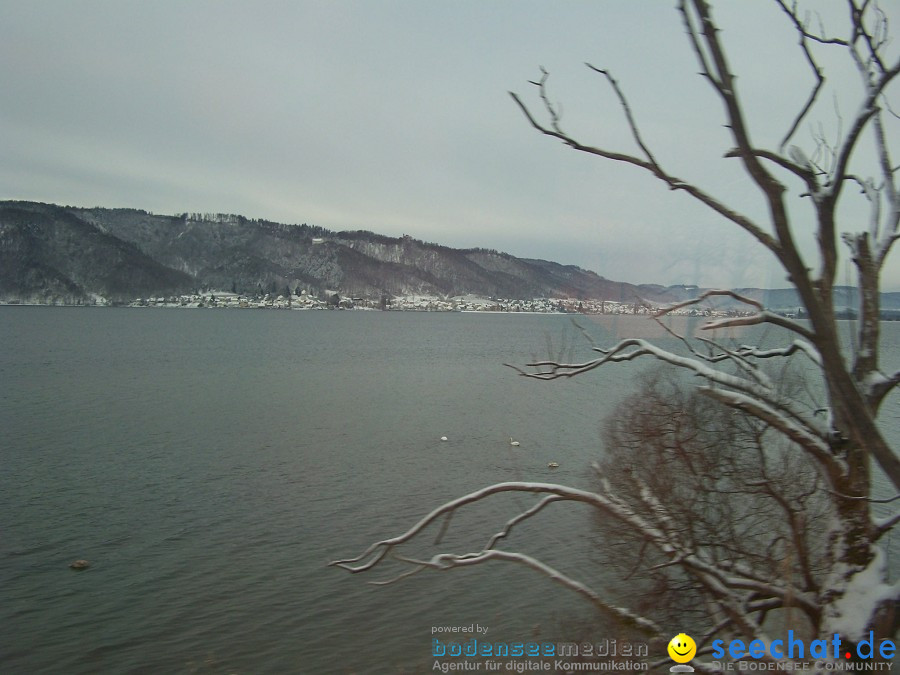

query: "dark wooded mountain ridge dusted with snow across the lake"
left=0, top=201, right=900, bottom=308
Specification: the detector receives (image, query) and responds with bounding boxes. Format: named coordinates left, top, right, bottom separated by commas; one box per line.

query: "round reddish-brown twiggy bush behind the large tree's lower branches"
left=597, top=370, right=834, bottom=645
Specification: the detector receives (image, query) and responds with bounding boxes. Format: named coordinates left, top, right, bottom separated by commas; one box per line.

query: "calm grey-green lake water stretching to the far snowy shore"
left=0, top=307, right=900, bottom=674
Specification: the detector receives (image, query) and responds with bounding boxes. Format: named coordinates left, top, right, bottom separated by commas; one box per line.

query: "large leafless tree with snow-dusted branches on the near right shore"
left=334, top=0, right=900, bottom=667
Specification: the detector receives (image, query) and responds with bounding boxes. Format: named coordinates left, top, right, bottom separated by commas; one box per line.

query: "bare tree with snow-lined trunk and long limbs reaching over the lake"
left=330, top=0, right=900, bottom=656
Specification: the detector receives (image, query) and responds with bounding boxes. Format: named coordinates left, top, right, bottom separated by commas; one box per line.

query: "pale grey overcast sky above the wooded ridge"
left=0, top=0, right=900, bottom=290
